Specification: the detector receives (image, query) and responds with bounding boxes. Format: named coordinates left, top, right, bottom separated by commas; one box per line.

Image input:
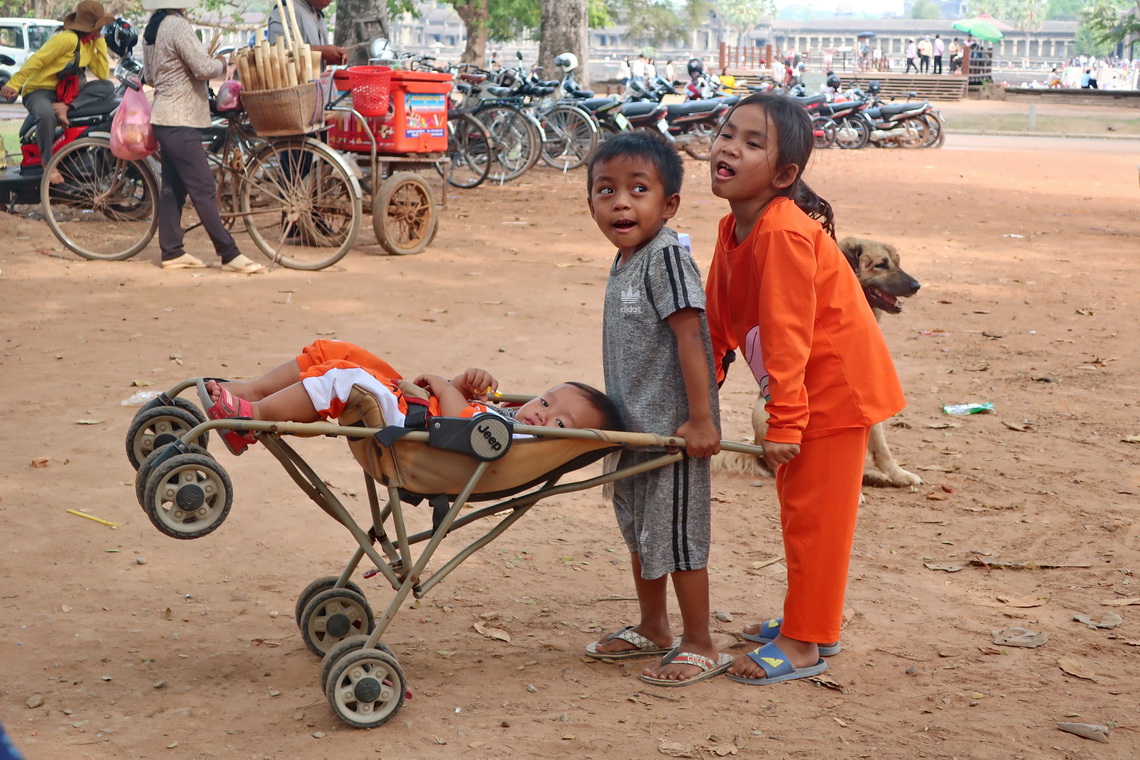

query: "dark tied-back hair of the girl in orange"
left=725, top=92, right=836, bottom=238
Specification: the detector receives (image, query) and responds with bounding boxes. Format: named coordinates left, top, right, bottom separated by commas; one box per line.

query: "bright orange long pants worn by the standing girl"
left=776, top=427, right=870, bottom=644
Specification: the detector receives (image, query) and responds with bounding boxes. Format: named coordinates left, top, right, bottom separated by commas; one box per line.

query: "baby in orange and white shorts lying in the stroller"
left=200, top=341, right=621, bottom=455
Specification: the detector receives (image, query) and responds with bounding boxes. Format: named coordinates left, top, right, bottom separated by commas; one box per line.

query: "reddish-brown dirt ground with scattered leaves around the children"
left=0, top=126, right=1140, bottom=760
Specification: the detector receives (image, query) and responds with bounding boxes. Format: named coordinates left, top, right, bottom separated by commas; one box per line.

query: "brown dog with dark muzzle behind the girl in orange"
left=713, top=237, right=922, bottom=487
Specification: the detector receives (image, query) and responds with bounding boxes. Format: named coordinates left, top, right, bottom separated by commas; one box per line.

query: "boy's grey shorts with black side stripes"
left=613, top=451, right=713, bottom=580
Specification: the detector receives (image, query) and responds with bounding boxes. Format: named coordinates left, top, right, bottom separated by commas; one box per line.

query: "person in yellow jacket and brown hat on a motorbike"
left=0, top=0, right=115, bottom=179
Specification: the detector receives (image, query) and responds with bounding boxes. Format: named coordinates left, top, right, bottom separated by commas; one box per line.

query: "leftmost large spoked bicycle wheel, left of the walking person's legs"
left=40, top=137, right=158, bottom=261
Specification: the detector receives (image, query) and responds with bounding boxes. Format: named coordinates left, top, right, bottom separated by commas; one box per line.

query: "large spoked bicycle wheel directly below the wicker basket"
left=237, top=138, right=363, bottom=270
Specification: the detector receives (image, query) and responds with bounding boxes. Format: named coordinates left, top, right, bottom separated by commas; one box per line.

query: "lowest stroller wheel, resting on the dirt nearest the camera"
left=325, top=649, right=407, bottom=728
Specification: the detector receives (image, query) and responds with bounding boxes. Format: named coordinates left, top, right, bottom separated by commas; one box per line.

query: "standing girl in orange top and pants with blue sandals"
left=706, top=93, right=905, bottom=684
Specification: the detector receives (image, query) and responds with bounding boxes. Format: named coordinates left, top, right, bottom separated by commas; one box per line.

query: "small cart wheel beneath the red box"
left=372, top=172, right=439, bottom=256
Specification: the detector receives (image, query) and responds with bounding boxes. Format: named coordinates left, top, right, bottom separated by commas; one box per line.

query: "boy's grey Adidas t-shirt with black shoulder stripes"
left=602, top=227, right=719, bottom=435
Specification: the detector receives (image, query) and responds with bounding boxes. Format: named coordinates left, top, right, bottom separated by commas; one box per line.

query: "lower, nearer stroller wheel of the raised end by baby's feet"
left=143, top=453, right=234, bottom=539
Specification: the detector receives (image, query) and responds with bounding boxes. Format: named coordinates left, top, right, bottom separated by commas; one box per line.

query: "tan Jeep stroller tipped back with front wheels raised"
left=127, top=377, right=762, bottom=728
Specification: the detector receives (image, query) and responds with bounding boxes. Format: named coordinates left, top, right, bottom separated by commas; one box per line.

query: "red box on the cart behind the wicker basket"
left=328, top=71, right=451, bottom=153
